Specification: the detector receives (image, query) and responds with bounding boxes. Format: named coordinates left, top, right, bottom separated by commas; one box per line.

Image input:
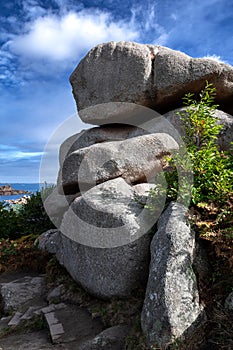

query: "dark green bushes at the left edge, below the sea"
left=0, top=189, right=54, bottom=239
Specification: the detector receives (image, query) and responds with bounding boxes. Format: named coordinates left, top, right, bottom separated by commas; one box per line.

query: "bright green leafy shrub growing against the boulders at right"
left=149, top=82, right=233, bottom=209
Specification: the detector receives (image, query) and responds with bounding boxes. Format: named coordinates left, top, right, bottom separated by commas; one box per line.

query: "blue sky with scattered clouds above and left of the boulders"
left=0, top=0, right=233, bottom=182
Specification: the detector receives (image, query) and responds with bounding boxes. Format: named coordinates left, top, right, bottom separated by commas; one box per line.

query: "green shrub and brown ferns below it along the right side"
left=148, top=82, right=233, bottom=349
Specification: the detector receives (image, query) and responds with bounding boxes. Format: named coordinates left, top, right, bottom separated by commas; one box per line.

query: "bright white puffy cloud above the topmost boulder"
left=8, top=10, right=139, bottom=61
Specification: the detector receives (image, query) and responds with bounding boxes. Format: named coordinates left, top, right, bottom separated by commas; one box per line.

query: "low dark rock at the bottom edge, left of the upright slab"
left=79, top=325, right=130, bottom=350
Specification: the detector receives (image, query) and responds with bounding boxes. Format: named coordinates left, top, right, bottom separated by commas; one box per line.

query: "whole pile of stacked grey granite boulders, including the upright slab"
left=40, top=42, right=233, bottom=348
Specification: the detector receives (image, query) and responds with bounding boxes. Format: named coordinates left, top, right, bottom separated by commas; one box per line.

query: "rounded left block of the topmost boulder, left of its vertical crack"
left=70, top=42, right=152, bottom=119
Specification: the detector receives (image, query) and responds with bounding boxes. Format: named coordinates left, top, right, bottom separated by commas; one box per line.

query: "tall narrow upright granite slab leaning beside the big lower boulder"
left=141, top=203, right=203, bottom=349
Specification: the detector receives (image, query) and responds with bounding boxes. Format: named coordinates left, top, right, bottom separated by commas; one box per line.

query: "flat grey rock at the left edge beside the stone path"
left=0, top=276, right=45, bottom=312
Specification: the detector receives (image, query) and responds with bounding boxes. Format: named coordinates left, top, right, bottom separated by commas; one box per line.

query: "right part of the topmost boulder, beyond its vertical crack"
left=153, top=46, right=233, bottom=111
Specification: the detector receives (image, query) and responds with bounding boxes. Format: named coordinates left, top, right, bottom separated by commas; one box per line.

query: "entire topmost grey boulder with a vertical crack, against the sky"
left=70, top=42, right=233, bottom=125
